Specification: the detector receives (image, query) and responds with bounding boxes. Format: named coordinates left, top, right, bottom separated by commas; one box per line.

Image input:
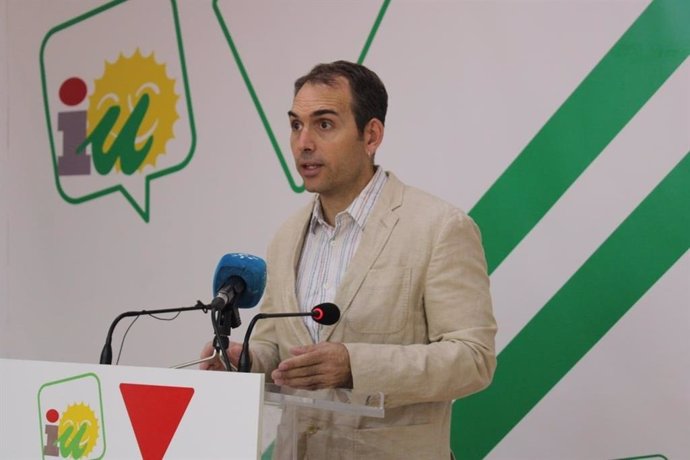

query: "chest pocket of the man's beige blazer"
left=345, top=267, right=412, bottom=334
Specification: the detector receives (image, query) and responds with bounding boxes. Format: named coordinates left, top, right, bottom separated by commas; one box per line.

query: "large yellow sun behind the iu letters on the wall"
left=87, top=48, right=180, bottom=172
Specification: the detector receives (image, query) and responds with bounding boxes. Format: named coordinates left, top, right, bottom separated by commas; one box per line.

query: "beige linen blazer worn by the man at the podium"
left=251, top=173, right=496, bottom=460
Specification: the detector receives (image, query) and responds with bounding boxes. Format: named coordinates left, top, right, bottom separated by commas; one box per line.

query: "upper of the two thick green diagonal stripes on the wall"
left=470, top=0, right=690, bottom=272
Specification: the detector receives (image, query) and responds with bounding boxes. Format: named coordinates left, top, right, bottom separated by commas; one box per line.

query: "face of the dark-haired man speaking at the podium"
left=288, top=78, right=374, bottom=206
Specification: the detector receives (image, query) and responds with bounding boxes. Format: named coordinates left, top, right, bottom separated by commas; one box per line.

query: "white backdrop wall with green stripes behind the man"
left=0, top=0, right=690, bottom=459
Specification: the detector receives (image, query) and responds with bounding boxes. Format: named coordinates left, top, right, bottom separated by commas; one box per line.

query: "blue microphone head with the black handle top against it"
left=210, top=253, right=266, bottom=308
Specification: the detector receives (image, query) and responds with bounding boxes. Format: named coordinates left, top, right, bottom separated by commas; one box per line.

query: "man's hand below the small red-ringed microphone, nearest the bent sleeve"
left=271, top=342, right=352, bottom=390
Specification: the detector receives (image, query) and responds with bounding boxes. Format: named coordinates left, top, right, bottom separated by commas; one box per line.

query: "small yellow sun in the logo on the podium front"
left=58, top=403, right=99, bottom=458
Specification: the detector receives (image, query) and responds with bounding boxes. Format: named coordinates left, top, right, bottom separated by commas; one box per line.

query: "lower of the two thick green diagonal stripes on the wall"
left=452, top=153, right=690, bottom=459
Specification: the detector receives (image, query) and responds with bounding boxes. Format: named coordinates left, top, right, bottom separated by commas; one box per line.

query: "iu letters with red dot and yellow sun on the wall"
left=57, top=49, right=179, bottom=176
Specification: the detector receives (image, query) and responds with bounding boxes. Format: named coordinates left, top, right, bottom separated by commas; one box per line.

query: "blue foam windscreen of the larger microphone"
left=213, top=253, right=266, bottom=308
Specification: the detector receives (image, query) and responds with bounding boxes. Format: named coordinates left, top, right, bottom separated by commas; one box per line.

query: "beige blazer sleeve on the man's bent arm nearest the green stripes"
left=345, top=209, right=496, bottom=407
